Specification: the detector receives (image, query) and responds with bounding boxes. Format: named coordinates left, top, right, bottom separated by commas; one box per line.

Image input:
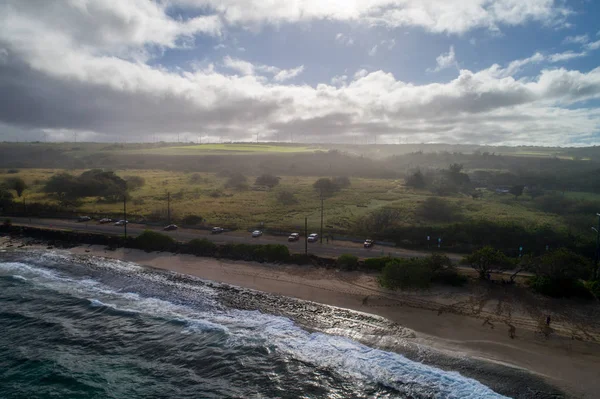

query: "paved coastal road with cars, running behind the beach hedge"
left=5, top=217, right=461, bottom=262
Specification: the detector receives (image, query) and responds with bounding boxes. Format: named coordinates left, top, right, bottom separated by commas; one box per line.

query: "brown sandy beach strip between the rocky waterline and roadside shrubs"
left=2, top=240, right=600, bottom=398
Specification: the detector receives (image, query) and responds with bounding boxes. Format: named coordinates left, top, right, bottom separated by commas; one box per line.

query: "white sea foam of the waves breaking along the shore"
left=0, top=262, right=503, bottom=399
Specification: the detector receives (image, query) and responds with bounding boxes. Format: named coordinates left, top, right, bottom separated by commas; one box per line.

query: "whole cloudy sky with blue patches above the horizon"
left=0, top=0, right=600, bottom=146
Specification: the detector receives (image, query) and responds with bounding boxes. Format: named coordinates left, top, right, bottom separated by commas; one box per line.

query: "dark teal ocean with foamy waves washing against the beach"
left=0, top=250, right=516, bottom=399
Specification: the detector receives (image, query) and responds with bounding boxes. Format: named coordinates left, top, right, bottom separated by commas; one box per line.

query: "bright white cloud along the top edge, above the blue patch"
left=171, top=0, right=571, bottom=34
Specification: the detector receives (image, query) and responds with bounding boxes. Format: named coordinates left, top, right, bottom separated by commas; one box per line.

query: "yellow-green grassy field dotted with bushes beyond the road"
left=0, top=169, right=565, bottom=232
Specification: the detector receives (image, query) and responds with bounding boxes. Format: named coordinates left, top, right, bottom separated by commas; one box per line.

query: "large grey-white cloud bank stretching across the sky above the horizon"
left=0, top=0, right=600, bottom=144
